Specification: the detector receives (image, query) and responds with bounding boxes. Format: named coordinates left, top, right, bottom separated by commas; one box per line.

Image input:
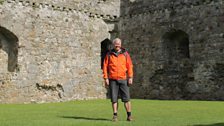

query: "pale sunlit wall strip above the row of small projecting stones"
left=29, top=0, right=120, bottom=17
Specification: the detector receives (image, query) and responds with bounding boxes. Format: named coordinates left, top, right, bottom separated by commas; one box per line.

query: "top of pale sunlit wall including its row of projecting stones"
left=1, top=0, right=120, bottom=20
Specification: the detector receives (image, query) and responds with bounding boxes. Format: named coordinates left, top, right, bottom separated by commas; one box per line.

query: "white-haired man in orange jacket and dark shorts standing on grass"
left=103, top=38, right=133, bottom=121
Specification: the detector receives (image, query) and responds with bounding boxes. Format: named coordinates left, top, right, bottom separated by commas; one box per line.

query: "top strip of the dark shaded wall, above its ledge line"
left=121, top=0, right=224, bottom=17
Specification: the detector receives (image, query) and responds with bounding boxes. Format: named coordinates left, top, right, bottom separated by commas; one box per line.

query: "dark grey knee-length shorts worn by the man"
left=109, top=80, right=130, bottom=102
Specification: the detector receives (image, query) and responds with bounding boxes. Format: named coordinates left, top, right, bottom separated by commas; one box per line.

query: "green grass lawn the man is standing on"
left=0, top=99, right=224, bottom=126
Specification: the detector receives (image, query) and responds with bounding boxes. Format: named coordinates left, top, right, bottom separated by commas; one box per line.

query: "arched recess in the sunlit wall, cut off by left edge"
left=0, top=26, right=19, bottom=72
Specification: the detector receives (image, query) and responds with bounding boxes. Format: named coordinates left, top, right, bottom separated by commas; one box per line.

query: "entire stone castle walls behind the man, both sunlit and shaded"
left=0, top=0, right=224, bottom=103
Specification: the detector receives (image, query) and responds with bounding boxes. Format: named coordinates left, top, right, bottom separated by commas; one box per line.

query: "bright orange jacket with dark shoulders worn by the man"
left=103, top=49, right=133, bottom=80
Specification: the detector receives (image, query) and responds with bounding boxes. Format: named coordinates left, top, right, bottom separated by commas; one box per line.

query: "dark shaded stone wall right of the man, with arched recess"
left=119, top=0, right=224, bottom=100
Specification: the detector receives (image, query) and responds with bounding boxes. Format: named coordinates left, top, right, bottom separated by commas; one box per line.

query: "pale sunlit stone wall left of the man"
left=0, top=0, right=119, bottom=103
